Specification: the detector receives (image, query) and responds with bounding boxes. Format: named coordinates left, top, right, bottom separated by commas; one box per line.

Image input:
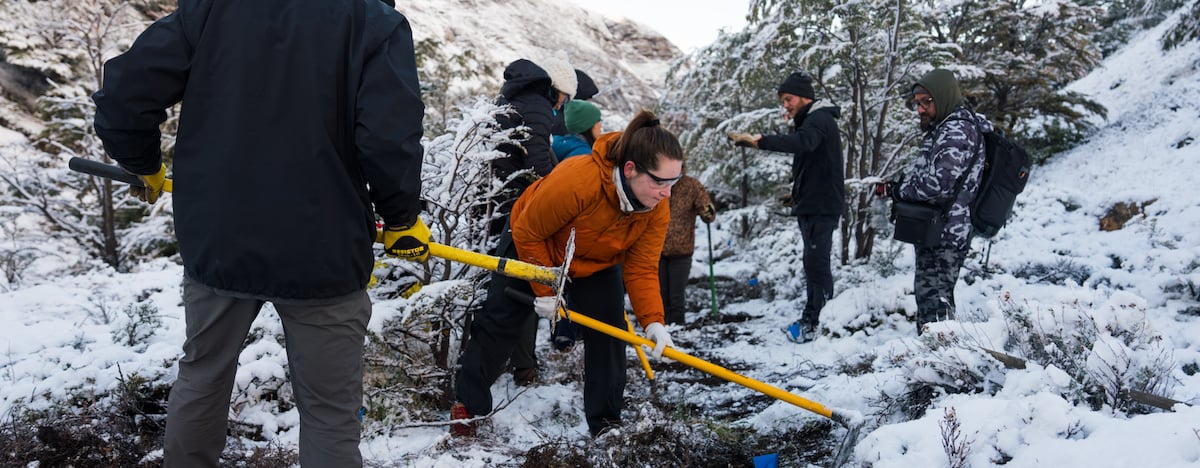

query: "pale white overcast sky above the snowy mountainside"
left=571, top=0, right=749, bottom=52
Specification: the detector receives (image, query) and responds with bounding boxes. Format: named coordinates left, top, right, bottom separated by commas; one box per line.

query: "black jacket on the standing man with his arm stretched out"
left=758, top=100, right=846, bottom=216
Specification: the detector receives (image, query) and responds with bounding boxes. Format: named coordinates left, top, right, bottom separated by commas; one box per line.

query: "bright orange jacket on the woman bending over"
left=511, top=132, right=671, bottom=328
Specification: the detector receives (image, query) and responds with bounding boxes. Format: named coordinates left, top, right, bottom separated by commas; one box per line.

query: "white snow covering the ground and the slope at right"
left=0, top=9, right=1200, bottom=468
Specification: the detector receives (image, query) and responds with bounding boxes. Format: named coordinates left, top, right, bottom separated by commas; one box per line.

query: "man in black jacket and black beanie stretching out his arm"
left=730, top=72, right=846, bottom=342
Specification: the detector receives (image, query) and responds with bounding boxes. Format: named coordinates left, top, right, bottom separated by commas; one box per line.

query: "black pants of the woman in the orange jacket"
left=455, top=234, right=625, bottom=434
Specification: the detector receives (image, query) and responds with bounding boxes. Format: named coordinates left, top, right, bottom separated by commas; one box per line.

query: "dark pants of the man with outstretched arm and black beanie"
left=798, top=215, right=838, bottom=326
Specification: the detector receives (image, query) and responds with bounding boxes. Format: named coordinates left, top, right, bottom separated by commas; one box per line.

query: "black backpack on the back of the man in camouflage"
left=971, top=131, right=1033, bottom=238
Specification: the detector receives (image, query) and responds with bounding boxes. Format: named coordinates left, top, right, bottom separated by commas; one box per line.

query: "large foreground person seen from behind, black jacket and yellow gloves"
left=92, top=0, right=430, bottom=467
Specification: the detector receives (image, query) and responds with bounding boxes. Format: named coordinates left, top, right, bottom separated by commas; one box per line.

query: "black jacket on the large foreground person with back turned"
left=92, top=0, right=425, bottom=300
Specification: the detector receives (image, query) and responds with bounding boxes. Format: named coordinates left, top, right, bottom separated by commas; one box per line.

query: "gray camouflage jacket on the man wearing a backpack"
left=896, top=107, right=994, bottom=248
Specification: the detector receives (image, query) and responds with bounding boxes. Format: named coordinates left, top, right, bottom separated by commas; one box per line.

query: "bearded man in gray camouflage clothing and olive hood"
left=876, top=68, right=994, bottom=335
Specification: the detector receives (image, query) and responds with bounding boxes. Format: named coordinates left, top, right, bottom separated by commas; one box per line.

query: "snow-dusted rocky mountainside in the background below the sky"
left=397, top=0, right=683, bottom=122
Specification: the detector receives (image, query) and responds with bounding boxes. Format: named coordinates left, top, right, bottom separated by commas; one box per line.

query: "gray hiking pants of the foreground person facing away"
left=163, top=277, right=371, bottom=468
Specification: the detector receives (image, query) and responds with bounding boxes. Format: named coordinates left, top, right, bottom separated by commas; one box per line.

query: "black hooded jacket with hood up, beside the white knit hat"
left=492, top=59, right=557, bottom=178
